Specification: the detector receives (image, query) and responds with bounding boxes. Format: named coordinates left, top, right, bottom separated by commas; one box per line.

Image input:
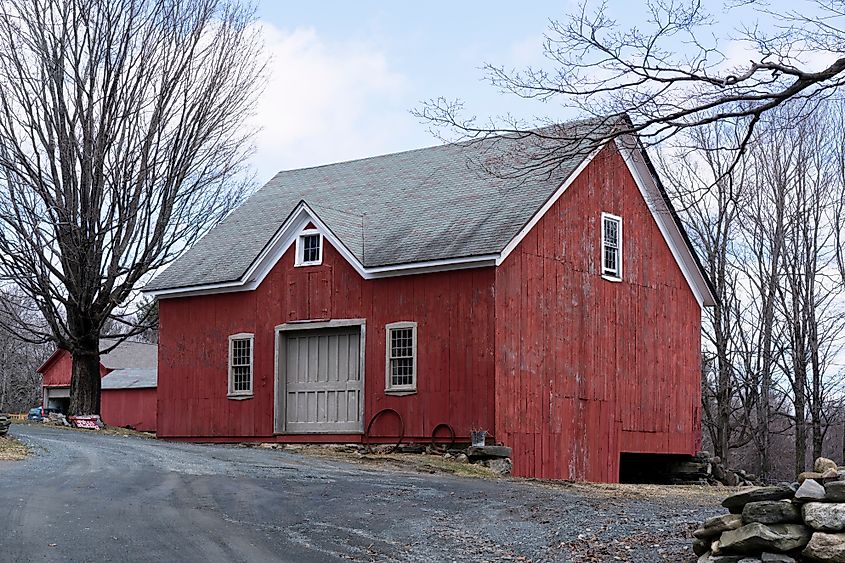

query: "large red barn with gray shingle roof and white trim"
left=146, top=122, right=713, bottom=481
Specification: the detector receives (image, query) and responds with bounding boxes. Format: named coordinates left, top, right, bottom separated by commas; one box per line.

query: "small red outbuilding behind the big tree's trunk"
left=38, top=340, right=158, bottom=431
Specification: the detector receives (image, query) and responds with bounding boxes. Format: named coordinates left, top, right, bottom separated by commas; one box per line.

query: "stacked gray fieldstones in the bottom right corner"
left=693, top=458, right=845, bottom=563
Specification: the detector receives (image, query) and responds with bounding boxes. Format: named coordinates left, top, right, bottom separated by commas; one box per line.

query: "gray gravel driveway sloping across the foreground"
left=0, top=425, right=721, bottom=563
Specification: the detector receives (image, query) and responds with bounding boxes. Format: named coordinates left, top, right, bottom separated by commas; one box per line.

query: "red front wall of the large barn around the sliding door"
left=157, top=240, right=495, bottom=441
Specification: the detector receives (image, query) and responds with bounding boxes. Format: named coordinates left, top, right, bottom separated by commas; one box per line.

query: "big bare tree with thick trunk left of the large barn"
left=0, top=0, right=263, bottom=414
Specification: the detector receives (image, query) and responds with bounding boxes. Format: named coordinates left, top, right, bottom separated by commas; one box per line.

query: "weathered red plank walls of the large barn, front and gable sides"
left=157, top=145, right=701, bottom=481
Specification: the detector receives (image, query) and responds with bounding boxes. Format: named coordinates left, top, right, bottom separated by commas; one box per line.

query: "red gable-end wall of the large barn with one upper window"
left=496, top=146, right=701, bottom=481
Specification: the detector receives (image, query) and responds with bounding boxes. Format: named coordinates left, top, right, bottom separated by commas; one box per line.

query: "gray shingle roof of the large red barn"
left=145, top=120, right=608, bottom=290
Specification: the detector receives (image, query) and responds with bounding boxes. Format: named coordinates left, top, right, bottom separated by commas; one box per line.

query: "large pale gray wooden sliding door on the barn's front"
left=277, top=326, right=364, bottom=433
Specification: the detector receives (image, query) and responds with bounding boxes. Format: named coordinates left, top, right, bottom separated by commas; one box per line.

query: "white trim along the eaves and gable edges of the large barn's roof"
left=147, top=140, right=715, bottom=305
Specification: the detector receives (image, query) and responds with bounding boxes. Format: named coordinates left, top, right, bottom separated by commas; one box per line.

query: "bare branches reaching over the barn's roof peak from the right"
left=415, top=0, right=845, bottom=182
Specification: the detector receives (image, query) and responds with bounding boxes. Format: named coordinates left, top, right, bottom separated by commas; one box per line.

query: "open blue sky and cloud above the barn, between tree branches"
left=246, top=0, right=832, bottom=185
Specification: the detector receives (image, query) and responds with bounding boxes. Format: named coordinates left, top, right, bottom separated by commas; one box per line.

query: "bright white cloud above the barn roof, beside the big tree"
left=244, top=22, right=420, bottom=182
